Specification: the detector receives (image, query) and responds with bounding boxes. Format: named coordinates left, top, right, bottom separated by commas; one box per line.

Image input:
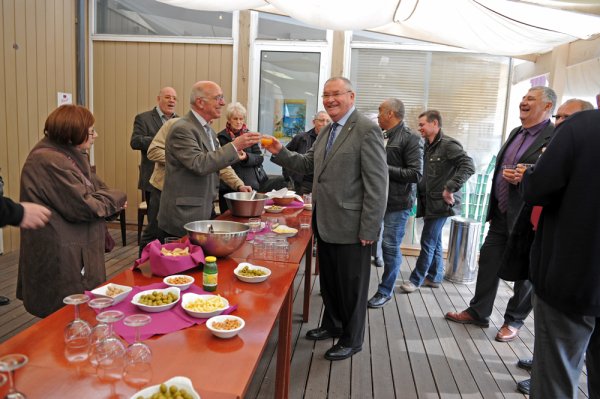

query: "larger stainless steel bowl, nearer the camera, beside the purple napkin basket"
left=183, top=220, right=250, bottom=257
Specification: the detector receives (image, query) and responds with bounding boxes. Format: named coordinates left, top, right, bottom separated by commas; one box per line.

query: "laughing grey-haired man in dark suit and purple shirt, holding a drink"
left=446, top=86, right=556, bottom=342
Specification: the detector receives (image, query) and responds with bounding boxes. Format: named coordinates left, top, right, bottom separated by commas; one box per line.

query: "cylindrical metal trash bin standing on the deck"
left=444, top=217, right=481, bottom=284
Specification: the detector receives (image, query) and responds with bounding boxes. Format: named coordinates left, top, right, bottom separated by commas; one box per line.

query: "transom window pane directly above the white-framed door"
left=257, top=13, right=327, bottom=40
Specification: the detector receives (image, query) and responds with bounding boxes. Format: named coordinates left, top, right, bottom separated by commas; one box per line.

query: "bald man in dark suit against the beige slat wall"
left=130, top=87, right=177, bottom=252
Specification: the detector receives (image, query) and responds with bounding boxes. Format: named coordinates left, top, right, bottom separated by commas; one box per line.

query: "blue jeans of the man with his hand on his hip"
left=410, top=217, right=447, bottom=287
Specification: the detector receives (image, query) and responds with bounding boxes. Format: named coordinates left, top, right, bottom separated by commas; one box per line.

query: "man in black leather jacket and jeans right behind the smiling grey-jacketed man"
left=368, top=98, right=423, bottom=308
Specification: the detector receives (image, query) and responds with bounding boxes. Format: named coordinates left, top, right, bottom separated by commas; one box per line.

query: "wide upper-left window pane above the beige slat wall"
left=95, top=0, right=232, bottom=38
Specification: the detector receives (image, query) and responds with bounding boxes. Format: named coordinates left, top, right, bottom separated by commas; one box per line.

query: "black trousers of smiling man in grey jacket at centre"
left=315, top=231, right=371, bottom=348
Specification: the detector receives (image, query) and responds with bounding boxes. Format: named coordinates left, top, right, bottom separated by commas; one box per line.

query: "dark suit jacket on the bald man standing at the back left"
left=130, top=108, right=163, bottom=191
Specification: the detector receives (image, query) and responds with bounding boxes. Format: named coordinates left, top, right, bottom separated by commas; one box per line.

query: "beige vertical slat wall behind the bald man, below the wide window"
left=92, top=41, right=233, bottom=228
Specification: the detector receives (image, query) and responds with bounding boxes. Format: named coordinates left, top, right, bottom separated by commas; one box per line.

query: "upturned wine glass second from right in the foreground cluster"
left=95, top=310, right=125, bottom=382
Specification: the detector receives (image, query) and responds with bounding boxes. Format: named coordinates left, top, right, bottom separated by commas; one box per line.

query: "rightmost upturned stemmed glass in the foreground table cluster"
left=123, top=314, right=152, bottom=388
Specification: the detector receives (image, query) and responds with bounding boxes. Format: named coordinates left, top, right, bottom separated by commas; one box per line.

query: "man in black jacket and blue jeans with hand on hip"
left=400, top=110, right=475, bottom=293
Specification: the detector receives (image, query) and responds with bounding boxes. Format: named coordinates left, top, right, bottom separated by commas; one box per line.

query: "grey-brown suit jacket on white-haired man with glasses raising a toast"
left=158, top=111, right=239, bottom=237
